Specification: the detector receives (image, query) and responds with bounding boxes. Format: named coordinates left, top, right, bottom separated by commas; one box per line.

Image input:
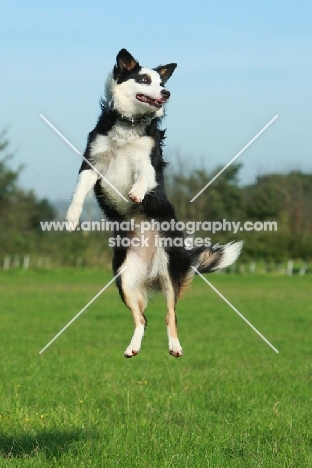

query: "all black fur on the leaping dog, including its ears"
left=73, top=49, right=239, bottom=308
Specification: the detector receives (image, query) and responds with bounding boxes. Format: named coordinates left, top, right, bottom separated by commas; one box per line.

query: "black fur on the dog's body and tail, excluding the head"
left=80, top=103, right=222, bottom=306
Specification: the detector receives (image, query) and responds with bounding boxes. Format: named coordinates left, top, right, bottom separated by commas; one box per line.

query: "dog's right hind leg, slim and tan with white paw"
left=160, top=274, right=183, bottom=357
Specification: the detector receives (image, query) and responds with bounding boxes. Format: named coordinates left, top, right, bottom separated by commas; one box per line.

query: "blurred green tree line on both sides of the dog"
left=0, top=133, right=312, bottom=266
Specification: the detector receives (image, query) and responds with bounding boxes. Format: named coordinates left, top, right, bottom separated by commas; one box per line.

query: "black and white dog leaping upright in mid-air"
left=66, top=49, right=242, bottom=357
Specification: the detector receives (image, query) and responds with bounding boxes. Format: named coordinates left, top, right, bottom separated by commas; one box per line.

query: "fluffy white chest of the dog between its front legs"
left=91, top=131, right=155, bottom=213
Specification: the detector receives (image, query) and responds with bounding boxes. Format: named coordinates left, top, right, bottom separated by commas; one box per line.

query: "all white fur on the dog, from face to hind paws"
left=66, top=58, right=242, bottom=357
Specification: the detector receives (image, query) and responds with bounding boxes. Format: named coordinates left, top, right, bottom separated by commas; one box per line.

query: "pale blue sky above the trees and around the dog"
left=0, top=0, right=312, bottom=200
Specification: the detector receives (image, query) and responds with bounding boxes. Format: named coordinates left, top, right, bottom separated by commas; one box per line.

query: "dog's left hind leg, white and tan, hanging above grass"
left=119, top=252, right=147, bottom=358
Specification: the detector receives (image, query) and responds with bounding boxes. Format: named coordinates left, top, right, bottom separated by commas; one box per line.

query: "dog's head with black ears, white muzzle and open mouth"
left=107, top=49, right=177, bottom=118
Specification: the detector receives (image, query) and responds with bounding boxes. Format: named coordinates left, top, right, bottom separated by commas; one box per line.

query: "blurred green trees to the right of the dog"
left=167, top=164, right=312, bottom=262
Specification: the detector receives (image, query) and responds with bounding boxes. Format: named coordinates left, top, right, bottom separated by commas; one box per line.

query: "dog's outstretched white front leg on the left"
left=66, top=169, right=98, bottom=231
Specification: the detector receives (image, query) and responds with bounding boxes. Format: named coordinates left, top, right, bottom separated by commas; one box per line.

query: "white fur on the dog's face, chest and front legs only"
left=66, top=68, right=169, bottom=230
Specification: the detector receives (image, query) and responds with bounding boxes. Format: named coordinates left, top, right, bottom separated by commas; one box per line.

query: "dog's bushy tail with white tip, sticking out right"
left=189, top=241, right=243, bottom=273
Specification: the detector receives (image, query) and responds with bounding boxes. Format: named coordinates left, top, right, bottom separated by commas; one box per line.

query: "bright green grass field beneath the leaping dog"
left=0, top=270, right=312, bottom=468
